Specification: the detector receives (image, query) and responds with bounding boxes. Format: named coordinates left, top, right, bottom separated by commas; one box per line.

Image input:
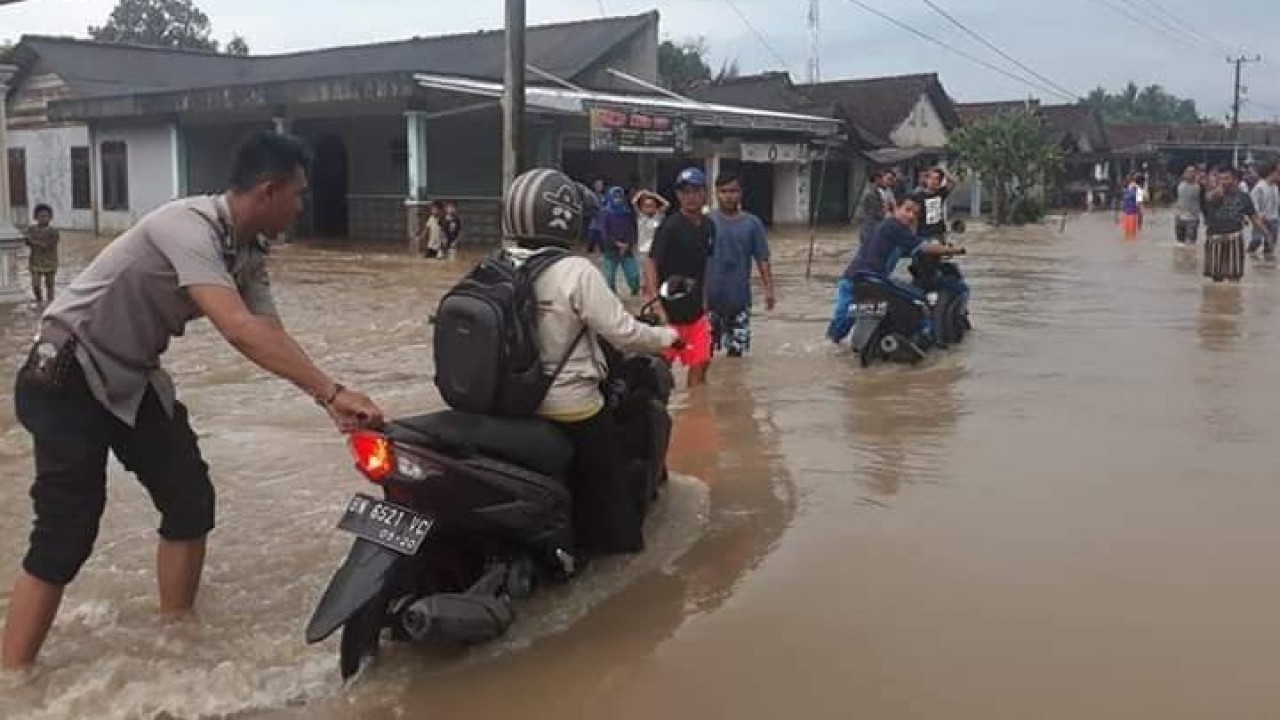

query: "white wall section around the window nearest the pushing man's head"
left=93, top=123, right=178, bottom=233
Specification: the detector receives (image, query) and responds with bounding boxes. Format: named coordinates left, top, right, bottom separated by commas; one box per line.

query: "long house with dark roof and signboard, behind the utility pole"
left=9, top=13, right=838, bottom=241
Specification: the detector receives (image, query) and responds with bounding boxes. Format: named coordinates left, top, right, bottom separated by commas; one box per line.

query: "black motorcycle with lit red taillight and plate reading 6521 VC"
left=306, top=286, right=678, bottom=680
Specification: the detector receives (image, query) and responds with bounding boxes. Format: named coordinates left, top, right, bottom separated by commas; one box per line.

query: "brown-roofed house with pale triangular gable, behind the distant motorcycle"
left=695, top=72, right=960, bottom=222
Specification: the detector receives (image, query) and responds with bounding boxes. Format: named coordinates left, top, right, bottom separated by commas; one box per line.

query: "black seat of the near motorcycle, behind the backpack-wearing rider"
left=387, top=410, right=573, bottom=478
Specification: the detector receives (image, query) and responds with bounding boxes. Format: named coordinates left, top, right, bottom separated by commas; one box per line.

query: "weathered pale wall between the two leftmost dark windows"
left=9, top=126, right=93, bottom=231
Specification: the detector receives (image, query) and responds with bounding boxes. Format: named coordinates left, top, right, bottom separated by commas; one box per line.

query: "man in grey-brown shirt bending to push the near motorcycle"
left=0, top=132, right=381, bottom=670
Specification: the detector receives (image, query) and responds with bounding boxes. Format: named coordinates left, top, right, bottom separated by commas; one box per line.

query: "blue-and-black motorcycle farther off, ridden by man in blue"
left=852, top=242, right=973, bottom=368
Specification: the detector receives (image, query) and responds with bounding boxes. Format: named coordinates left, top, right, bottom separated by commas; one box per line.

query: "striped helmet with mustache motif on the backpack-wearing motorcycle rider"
left=502, top=168, right=588, bottom=246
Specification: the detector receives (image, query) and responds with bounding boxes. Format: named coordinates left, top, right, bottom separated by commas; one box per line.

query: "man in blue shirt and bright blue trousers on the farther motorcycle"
left=827, top=196, right=956, bottom=342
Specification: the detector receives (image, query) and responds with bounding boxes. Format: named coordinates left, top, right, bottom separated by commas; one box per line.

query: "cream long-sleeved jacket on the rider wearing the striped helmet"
left=508, top=249, right=678, bottom=423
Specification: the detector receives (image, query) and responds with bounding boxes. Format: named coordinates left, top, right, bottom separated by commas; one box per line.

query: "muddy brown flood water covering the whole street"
left=0, top=214, right=1280, bottom=720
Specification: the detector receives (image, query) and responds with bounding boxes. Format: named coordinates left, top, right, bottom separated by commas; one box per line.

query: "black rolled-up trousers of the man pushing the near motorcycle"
left=14, top=351, right=214, bottom=585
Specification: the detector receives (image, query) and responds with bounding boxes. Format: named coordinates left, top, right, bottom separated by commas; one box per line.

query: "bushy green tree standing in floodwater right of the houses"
left=951, top=110, right=1062, bottom=224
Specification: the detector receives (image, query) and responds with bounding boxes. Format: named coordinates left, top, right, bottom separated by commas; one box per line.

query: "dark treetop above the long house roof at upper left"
left=88, top=0, right=248, bottom=55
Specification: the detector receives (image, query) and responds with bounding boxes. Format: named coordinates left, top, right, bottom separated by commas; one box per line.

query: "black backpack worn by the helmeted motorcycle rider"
left=434, top=250, right=586, bottom=416
